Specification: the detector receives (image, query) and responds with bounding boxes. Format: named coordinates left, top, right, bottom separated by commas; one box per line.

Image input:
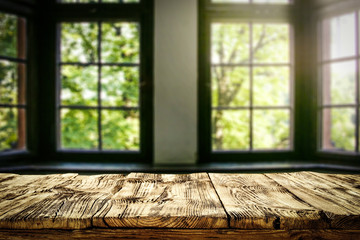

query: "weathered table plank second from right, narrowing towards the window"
left=209, top=173, right=328, bottom=229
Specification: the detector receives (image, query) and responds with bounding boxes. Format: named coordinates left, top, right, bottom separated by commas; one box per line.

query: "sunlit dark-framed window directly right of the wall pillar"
left=199, top=0, right=295, bottom=161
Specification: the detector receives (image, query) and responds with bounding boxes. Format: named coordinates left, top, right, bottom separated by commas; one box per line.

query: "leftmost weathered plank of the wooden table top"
left=0, top=174, right=124, bottom=229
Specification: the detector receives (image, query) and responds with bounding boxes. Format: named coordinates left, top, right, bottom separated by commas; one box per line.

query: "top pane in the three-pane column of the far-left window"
left=0, top=12, right=26, bottom=59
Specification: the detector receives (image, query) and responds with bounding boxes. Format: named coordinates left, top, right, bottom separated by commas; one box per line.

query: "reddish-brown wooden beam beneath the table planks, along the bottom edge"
left=0, top=229, right=360, bottom=240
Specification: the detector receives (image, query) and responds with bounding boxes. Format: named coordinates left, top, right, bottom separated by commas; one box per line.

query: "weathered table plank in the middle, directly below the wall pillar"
left=94, top=173, right=228, bottom=228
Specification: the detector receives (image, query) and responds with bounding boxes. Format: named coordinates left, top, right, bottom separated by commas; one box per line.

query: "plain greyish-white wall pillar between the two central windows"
left=154, top=0, right=197, bottom=164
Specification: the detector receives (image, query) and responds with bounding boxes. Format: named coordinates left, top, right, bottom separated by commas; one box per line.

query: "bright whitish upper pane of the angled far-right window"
left=322, top=13, right=356, bottom=60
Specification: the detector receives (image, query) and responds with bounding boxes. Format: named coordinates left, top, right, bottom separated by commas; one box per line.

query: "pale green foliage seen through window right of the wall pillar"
left=212, top=23, right=290, bottom=150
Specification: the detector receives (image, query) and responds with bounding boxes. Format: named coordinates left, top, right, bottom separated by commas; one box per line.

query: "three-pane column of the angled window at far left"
left=0, top=12, right=27, bottom=152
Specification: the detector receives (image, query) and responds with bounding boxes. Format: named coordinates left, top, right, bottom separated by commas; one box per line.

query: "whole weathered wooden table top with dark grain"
left=0, top=172, right=360, bottom=231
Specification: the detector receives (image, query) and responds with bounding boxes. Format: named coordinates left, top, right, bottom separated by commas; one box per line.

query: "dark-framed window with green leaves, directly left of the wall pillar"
left=33, top=0, right=153, bottom=163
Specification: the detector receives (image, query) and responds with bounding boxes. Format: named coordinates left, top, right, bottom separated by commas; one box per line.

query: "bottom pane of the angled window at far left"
left=0, top=108, right=26, bottom=151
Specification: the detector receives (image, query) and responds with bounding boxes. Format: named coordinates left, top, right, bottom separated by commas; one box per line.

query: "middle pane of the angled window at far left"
left=0, top=60, right=26, bottom=104
